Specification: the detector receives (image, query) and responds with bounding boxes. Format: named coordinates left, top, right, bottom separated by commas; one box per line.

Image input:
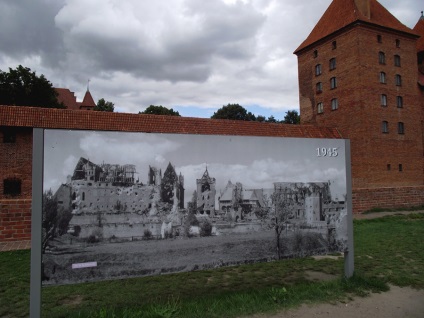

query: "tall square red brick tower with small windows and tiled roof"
left=294, top=0, right=424, bottom=188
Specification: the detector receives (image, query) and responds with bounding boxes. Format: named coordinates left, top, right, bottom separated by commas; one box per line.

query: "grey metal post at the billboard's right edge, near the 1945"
left=344, top=140, right=355, bottom=278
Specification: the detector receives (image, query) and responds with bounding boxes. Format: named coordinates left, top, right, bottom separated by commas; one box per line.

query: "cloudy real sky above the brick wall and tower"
left=0, top=0, right=424, bottom=119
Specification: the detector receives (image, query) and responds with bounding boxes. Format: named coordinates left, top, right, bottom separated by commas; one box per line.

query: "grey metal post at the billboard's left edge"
left=29, top=128, right=44, bottom=318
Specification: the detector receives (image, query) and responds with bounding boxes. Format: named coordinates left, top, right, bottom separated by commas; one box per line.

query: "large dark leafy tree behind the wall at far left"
left=0, top=65, right=66, bottom=108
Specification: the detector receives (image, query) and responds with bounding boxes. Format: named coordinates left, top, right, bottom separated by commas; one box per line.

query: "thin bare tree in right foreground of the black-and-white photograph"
left=271, top=188, right=294, bottom=259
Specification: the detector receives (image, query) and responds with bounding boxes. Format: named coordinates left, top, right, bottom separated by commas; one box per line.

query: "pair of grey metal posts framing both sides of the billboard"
left=30, top=128, right=354, bottom=318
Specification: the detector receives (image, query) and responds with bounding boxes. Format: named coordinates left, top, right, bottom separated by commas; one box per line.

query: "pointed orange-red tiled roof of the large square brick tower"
left=294, top=0, right=414, bottom=54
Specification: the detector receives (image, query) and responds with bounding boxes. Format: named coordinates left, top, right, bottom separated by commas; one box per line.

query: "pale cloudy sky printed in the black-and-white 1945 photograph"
left=44, top=130, right=346, bottom=201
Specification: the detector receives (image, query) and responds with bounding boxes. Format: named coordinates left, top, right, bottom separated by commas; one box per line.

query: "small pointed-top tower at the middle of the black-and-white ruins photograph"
left=196, top=168, right=216, bottom=215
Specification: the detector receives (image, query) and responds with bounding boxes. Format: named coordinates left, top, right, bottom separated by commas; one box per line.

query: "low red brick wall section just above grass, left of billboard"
left=0, top=199, right=31, bottom=242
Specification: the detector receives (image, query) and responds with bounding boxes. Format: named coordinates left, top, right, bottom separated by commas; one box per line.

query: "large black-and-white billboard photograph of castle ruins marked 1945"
left=42, top=129, right=352, bottom=285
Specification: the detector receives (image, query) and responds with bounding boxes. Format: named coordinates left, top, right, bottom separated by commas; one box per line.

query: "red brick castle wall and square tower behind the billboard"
left=0, top=0, right=424, bottom=241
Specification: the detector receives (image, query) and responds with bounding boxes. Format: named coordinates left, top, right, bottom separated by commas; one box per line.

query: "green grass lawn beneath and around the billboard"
left=0, top=214, right=424, bottom=318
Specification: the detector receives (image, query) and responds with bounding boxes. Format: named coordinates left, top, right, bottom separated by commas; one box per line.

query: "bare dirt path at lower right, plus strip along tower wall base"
left=251, top=211, right=424, bottom=318
